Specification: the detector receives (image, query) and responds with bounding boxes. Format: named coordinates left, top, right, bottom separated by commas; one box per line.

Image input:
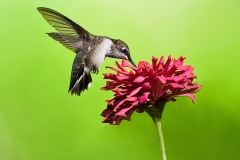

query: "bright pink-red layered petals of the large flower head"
left=101, top=56, right=202, bottom=124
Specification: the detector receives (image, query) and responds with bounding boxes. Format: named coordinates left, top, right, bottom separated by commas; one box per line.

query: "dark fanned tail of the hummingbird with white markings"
left=69, top=71, right=92, bottom=96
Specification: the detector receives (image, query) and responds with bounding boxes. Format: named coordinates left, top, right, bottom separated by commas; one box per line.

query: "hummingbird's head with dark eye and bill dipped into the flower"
left=107, top=39, right=137, bottom=67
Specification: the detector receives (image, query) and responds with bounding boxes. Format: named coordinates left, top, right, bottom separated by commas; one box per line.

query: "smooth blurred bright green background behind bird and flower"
left=0, top=0, right=240, bottom=160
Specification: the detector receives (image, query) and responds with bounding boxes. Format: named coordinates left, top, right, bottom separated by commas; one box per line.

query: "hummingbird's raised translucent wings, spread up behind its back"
left=37, top=7, right=92, bottom=53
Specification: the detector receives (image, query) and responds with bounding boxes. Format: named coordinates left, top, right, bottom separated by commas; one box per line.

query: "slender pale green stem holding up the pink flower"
left=152, top=117, right=167, bottom=160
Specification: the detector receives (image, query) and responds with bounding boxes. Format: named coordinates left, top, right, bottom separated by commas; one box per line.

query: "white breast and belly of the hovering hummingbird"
left=86, top=37, right=113, bottom=70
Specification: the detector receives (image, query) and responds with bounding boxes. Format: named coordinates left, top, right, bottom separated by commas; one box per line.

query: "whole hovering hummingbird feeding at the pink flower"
left=37, top=7, right=136, bottom=96
